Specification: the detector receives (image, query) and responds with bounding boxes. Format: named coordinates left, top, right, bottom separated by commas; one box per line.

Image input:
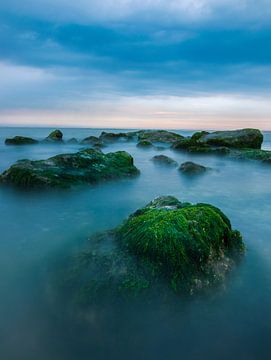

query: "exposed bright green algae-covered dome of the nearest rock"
left=117, top=197, right=244, bottom=290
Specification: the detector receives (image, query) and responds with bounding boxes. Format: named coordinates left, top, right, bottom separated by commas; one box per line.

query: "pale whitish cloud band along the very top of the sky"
left=0, top=0, right=271, bottom=26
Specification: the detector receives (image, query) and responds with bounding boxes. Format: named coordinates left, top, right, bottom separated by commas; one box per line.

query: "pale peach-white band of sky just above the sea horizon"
left=0, top=94, right=271, bottom=130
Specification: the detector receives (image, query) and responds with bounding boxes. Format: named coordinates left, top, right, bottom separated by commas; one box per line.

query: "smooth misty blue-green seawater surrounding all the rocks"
left=0, top=128, right=271, bottom=360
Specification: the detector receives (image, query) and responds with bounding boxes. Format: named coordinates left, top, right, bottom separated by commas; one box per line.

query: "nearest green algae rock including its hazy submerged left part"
left=61, top=196, right=244, bottom=303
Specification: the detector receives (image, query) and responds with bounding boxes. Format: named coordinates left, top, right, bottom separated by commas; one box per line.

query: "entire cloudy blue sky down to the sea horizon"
left=0, top=0, right=271, bottom=130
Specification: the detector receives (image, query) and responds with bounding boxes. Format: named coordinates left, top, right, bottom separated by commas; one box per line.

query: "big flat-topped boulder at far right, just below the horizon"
left=198, top=129, right=263, bottom=149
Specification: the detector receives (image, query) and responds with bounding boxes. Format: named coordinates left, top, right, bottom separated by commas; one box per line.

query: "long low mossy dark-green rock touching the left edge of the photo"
left=0, top=149, right=139, bottom=188
